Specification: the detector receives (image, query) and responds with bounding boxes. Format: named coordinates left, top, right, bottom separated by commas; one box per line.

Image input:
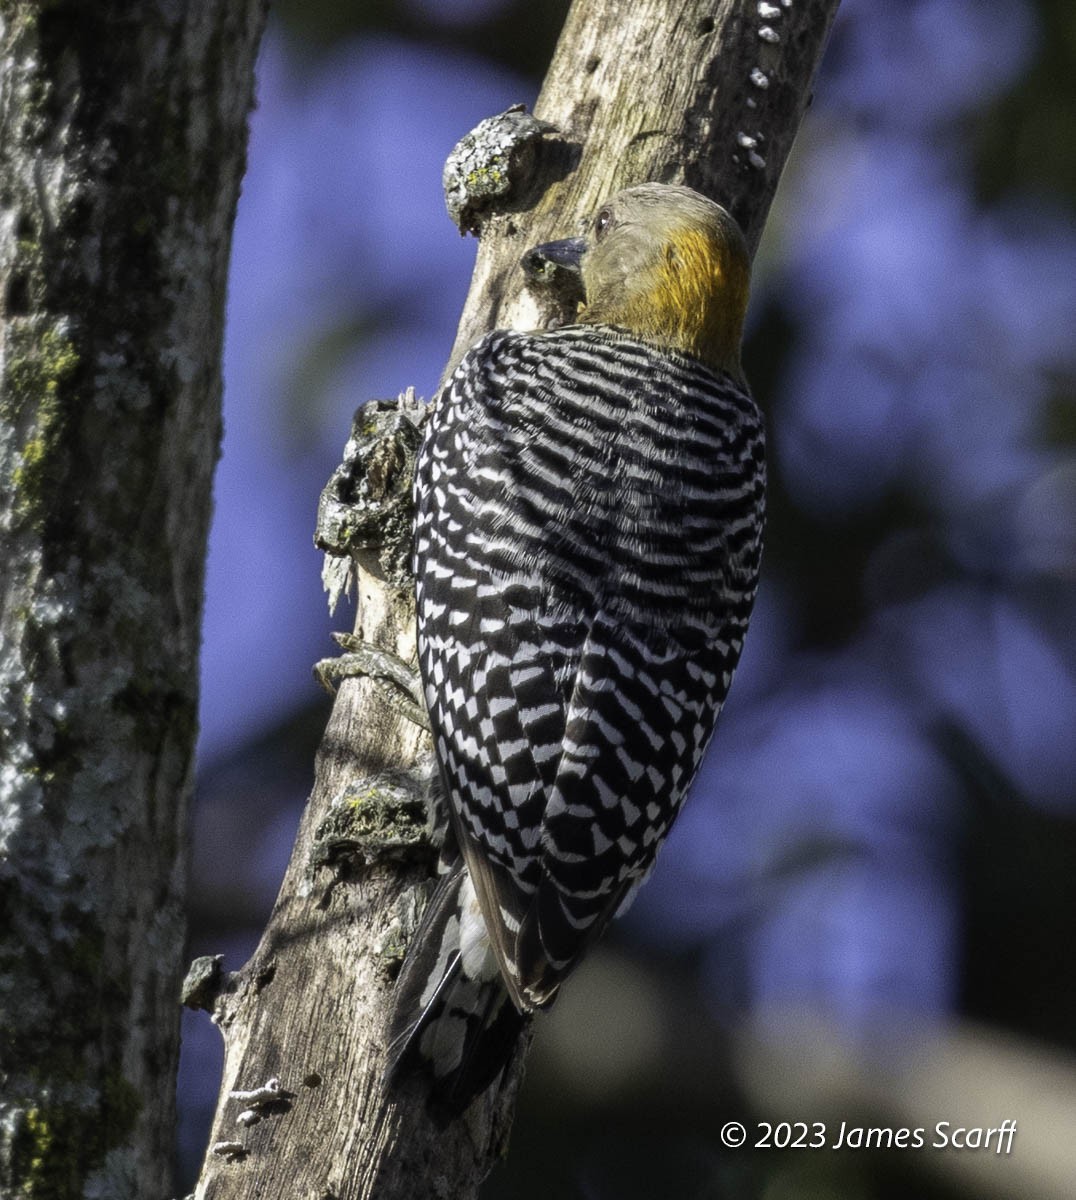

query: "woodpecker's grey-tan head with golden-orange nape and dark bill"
left=524, top=184, right=751, bottom=379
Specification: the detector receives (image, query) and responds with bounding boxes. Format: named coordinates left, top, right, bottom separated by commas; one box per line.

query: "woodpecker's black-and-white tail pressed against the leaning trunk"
left=385, top=862, right=528, bottom=1123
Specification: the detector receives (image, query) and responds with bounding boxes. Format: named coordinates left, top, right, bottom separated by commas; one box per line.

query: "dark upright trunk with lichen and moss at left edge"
left=0, top=0, right=264, bottom=1200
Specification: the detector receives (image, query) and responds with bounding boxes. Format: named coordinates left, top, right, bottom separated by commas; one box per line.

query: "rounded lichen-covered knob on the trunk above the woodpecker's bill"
left=443, top=104, right=557, bottom=235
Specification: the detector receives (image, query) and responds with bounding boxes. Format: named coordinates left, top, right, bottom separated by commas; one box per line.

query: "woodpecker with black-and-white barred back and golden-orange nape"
left=389, top=184, right=765, bottom=1118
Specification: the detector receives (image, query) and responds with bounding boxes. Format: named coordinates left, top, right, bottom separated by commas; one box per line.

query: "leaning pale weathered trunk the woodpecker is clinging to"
left=198, top=0, right=837, bottom=1200
